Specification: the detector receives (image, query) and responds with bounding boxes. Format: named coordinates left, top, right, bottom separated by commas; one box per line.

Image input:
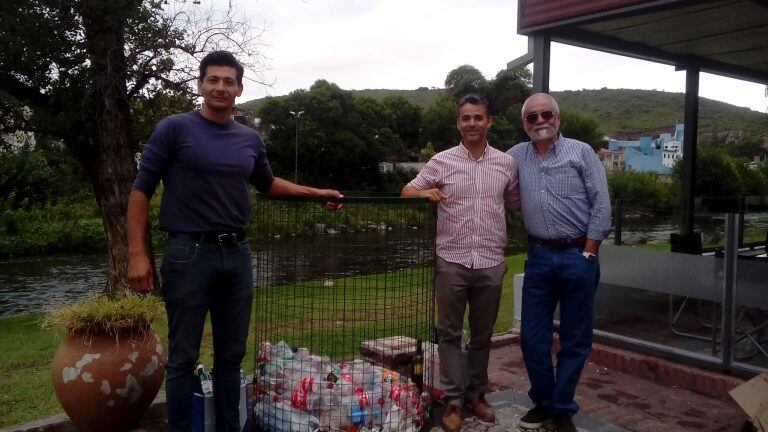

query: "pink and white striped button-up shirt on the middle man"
left=408, top=144, right=520, bottom=268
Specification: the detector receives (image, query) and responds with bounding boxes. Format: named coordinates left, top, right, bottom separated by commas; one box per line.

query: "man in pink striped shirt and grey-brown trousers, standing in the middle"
left=402, top=94, right=520, bottom=432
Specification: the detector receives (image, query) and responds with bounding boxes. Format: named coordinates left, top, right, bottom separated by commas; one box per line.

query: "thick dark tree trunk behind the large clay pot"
left=73, top=0, right=138, bottom=295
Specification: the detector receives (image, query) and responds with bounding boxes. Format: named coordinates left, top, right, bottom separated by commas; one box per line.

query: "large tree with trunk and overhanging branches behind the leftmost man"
left=0, top=0, right=268, bottom=293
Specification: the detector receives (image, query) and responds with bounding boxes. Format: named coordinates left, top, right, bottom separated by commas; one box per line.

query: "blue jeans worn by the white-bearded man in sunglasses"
left=520, top=245, right=600, bottom=414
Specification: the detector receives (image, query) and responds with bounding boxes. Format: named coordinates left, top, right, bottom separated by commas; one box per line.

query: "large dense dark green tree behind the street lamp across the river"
left=259, top=80, right=396, bottom=191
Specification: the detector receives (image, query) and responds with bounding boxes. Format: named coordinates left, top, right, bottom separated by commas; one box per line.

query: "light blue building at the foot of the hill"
left=608, top=123, right=684, bottom=174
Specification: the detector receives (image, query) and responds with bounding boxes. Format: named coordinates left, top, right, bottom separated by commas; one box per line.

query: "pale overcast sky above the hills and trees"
left=230, top=0, right=768, bottom=112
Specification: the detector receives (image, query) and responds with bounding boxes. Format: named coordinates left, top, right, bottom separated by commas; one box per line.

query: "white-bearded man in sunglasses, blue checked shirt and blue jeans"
left=507, top=93, right=611, bottom=432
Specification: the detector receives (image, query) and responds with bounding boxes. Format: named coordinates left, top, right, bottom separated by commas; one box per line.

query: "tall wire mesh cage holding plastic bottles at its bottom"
left=249, top=197, right=436, bottom=432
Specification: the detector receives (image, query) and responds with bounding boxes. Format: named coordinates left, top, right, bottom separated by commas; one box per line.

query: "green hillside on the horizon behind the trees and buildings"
left=240, top=87, right=768, bottom=139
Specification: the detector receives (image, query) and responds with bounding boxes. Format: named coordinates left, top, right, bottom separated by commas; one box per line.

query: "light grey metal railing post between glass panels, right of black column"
left=721, top=213, right=740, bottom=366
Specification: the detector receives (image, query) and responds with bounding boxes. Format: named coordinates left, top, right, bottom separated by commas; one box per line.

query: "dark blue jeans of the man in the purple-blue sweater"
left=160, top=238, right=253, bottom=432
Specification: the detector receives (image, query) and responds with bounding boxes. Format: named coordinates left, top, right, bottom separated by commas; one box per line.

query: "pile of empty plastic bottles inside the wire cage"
left=254, top=341, right=431, bottom=432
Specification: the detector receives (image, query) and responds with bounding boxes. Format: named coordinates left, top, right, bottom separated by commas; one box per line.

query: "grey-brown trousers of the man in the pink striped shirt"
left=435, top=257, right=507, bottom=406
